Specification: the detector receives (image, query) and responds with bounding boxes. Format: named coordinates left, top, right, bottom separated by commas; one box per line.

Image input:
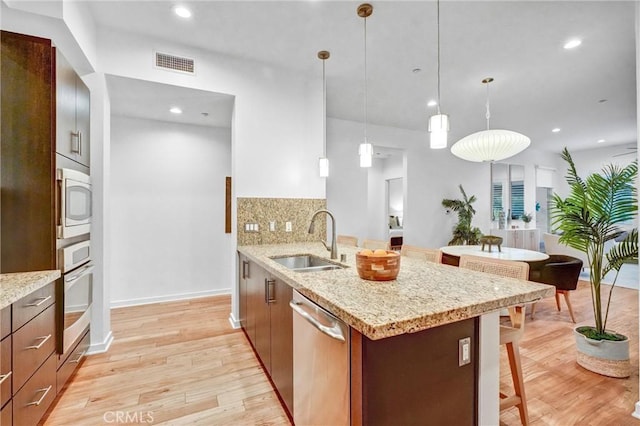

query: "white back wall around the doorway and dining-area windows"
left=327, top=118, right=562, bottom=247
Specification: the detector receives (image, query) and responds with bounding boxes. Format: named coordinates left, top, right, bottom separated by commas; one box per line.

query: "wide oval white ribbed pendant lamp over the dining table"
left=451, top=77, right=531, bottom=162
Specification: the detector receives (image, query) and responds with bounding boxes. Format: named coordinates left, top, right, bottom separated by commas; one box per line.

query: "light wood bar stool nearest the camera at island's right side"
left=460, top=255, right=529, bottom=425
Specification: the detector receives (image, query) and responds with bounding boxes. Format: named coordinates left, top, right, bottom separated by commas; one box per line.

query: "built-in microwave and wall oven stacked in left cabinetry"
left=56, top=169, right=94, bottom=362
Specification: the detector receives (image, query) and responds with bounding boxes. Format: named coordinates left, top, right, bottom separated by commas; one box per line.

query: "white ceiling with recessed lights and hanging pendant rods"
left=90, top=0, right=637, bottom=151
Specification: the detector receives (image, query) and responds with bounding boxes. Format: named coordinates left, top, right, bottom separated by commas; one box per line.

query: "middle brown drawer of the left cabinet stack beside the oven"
left=13, top=304, right=56, bottom=392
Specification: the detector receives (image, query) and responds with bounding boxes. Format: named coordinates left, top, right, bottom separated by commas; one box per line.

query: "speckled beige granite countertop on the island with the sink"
left=238, top=243, right=555, bottom=340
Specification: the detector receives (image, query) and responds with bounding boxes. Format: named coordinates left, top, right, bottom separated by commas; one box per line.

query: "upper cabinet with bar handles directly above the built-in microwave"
left=56, top=46, right=90, bottom=167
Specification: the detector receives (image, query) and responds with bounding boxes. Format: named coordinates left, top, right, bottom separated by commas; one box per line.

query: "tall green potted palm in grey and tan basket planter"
left=551, top=148, right=638, bottom=377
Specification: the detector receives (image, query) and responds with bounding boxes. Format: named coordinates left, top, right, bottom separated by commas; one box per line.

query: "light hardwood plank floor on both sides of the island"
left=45, top=283, right=640, bottom=426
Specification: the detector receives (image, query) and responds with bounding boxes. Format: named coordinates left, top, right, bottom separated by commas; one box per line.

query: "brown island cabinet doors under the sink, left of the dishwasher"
left=239, top=254, right=293, bottom=414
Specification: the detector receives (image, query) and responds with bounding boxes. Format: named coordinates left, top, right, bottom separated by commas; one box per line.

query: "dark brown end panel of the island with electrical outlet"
left=351, top=318, right=479, bottom=425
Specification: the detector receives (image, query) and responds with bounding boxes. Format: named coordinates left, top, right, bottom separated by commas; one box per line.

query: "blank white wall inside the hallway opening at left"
left=110, top=117, right=233, bottom=306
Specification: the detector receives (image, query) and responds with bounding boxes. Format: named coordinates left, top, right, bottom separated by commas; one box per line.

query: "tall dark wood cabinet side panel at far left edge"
left=0, top=31, right=56, bottom=272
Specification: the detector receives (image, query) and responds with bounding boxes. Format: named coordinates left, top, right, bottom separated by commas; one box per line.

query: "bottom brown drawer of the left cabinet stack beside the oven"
left=13, top=354, right=56, bottom=426
